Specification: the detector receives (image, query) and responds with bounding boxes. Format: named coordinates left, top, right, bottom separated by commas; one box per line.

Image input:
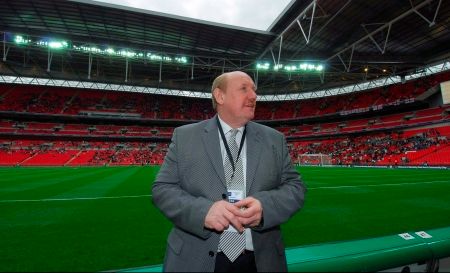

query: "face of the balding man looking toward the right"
left=221, top=72, right=256, bottom=126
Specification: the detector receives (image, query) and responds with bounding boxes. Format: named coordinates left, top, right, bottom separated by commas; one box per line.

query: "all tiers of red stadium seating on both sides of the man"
left=0, top=72, right=450, bottom=166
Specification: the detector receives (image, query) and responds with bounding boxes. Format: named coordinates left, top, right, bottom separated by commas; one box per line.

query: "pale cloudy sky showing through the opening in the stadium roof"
left=96, top=0, right=291, bottom=31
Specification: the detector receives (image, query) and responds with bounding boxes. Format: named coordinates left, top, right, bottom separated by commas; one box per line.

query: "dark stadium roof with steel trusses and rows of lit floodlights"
left=0, top=0, right=450, bottom=94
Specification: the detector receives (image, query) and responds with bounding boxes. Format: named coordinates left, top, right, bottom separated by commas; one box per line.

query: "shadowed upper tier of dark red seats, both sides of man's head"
left=0, top=70, right=450, bottom=120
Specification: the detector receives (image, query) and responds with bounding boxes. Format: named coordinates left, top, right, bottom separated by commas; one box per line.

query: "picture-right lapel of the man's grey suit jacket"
left=246, top=122, right=261, bottom=195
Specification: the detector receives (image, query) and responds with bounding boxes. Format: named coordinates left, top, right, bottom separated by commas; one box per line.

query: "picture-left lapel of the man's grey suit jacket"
left=202, top=117, right=227, bottom=187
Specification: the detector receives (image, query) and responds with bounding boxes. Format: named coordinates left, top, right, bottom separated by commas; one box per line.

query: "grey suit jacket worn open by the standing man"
left=152, top=118, right=306, bottom=272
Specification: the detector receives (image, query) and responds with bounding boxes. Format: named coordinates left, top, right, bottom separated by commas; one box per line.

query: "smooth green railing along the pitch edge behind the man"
left=120, top=224, right=450, bottom=272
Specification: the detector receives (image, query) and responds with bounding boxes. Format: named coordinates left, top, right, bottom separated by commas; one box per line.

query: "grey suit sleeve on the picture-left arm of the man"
left=152, top=129, right=213, bottom=239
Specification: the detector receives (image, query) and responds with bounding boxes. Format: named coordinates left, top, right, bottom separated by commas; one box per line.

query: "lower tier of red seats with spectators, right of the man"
left=290, top=125, right=450, bottom=166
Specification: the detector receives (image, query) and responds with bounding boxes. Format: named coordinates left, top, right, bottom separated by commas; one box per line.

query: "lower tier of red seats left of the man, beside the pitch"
left=0, top=139, right=167, bottom=166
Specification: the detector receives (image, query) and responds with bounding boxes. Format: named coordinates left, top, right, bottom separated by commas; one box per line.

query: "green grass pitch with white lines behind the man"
left=0, top=167, right=450, bottom=271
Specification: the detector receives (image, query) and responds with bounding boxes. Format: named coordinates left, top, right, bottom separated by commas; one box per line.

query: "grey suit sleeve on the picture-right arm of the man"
left=253, top=133, right=306, bottom=231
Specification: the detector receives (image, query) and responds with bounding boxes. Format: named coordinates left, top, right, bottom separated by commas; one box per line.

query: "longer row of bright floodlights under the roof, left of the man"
left=13, top=35, right=188, bottom=64
